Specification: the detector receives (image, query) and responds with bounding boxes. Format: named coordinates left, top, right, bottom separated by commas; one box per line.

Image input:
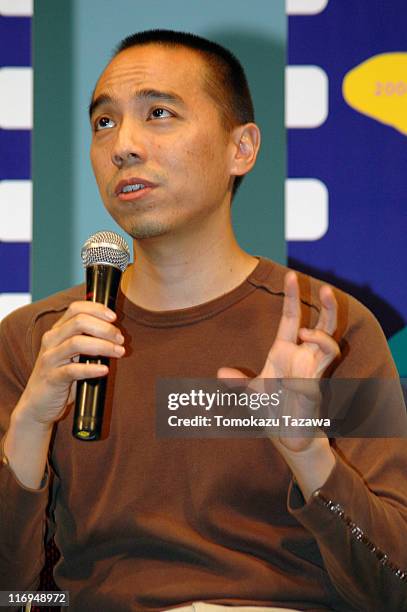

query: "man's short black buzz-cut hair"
left=113, top=30, right=254, bottom=195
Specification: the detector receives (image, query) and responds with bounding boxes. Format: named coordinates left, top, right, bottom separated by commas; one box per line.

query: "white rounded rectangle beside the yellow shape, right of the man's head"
left=285, top=66, right=328, bottom=128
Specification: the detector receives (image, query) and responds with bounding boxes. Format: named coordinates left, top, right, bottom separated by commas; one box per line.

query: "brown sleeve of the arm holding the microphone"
left=0, top=310, right=50, bottom=590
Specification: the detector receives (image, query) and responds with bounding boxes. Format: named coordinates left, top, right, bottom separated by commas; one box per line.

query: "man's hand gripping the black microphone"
left=15, top=301, right=124, bottom=428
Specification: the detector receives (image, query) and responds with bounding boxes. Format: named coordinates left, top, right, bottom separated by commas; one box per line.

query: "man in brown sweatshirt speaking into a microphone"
left=0, top=31, right=407, bottom=612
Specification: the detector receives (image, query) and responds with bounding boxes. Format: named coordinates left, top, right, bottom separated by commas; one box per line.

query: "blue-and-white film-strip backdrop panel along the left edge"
left=0, top=0, right=32, bottom=319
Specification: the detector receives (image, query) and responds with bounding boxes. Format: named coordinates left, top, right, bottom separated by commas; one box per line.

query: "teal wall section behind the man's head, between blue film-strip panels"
left=32, top=0, right=286, bottom=299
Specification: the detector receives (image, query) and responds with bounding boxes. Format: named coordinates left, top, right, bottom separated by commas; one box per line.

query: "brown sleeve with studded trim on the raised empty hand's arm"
left=288, top=294, right=407, bottom=612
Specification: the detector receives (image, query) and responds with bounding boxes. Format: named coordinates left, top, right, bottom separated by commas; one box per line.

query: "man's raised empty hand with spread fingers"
left=218, top=271, right=340, bottom=454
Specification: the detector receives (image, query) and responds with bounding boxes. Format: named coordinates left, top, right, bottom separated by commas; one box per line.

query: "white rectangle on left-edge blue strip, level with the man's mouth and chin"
left=0, top=181, right=32, bottom=242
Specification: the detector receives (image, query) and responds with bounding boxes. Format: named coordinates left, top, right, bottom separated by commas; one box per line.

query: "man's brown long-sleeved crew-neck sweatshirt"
left=0, top=259, right=407, bottom=612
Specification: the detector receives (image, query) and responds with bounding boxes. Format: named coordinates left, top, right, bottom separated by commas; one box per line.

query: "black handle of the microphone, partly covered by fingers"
left=72, top=264, right=122, bottom=441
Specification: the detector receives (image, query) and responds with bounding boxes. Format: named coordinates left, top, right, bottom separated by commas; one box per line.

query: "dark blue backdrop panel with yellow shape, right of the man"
left=288, top=0, right=407, bottom=375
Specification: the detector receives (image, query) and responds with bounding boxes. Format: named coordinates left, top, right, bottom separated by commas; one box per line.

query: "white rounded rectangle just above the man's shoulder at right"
left=285, top=178, right=329, bottom=240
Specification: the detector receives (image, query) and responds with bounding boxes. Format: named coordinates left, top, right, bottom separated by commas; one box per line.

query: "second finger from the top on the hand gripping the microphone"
left=42, top=313, right=124, bottom=348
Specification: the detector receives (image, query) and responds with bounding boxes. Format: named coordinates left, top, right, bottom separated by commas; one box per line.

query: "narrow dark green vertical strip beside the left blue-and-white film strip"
left=31, top=0, right=74, bottom=300
